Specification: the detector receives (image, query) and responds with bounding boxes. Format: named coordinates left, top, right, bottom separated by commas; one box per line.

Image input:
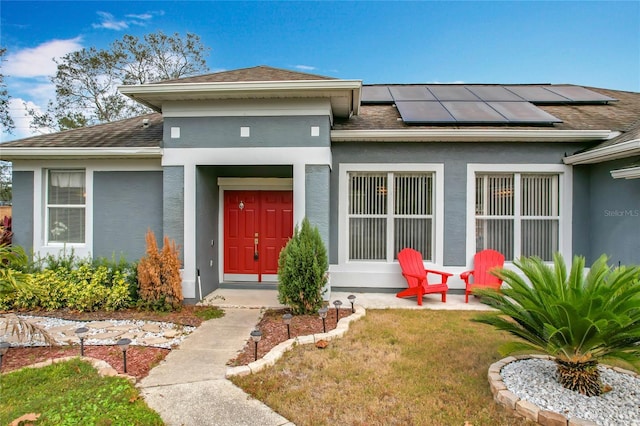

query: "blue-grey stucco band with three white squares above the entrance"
left=164, top=116, right=329, bottom=148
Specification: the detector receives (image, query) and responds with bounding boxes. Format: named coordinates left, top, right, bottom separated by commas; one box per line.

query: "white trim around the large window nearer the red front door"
left=338, top=163, right=444, bottom=269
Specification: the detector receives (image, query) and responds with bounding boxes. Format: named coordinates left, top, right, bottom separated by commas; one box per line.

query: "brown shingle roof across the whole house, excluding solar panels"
left=0, top=66, right=640, bottom=150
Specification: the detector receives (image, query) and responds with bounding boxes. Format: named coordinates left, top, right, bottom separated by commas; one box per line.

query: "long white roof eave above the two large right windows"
left=331, top=129, right=612, bottom=142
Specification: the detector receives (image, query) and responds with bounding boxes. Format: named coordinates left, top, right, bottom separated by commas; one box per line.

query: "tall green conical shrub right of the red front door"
left=278, top=218, right=329, bottom=315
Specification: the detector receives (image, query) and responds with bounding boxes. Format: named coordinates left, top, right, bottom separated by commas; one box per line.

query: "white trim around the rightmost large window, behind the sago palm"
left=466, top=164, right=573, bottom=268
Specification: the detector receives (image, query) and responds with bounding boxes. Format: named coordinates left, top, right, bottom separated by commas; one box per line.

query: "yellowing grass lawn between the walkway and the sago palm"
left=233, top=310, right=530, bottom=426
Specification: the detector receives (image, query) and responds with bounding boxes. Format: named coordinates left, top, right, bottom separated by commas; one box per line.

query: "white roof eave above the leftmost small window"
left=0, top=146, right=162, bottom=161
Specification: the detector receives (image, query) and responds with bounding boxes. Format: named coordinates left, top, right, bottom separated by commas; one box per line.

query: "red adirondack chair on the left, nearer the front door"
left=396, top=248, right=453, bottom=306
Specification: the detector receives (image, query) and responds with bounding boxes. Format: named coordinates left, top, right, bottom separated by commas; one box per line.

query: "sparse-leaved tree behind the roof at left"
left=28, top=31, right=208, bottom=130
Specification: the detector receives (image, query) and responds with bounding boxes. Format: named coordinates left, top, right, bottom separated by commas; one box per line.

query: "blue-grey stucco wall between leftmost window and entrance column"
left=93, top=171, right=163, bottom=261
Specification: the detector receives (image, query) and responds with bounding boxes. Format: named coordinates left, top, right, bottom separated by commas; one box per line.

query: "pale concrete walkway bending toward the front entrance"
left=138, top=309, right=292, bottom=426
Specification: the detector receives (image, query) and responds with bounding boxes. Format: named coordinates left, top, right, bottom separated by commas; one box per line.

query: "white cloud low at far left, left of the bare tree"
left=3, top=37, right=82, bottom=78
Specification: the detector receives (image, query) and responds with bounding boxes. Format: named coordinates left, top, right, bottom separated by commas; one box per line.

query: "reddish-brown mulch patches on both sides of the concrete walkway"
left=0, top=306, right=351, bottom=380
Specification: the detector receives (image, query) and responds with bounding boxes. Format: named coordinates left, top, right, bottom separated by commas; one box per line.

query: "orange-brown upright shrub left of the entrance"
left=138, top=230, right=183, bottom=310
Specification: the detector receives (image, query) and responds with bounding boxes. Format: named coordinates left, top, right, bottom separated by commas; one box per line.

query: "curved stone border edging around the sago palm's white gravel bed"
left=487, top=355, right=639, bottom=426
